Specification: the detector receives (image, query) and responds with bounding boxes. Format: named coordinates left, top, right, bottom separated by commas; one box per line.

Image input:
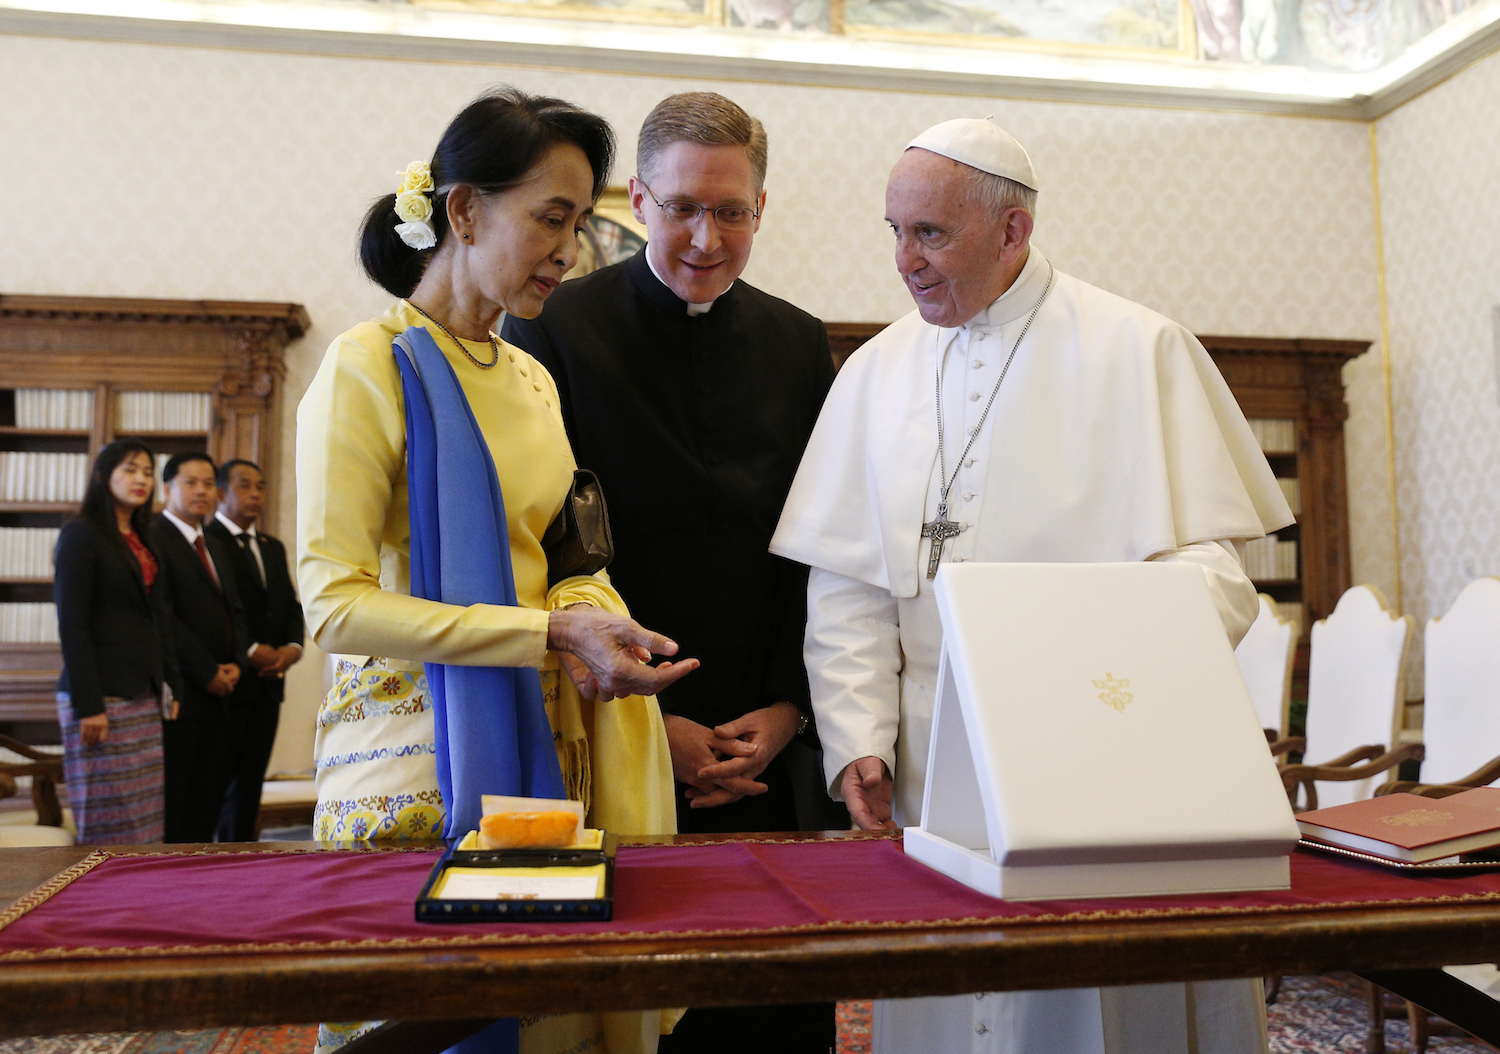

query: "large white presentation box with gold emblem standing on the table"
left=906, top=562, right=1298, bottom=900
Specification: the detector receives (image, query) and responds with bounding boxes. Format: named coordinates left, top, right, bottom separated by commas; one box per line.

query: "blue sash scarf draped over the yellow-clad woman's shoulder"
left=395, top=327, right=567, bottom=1054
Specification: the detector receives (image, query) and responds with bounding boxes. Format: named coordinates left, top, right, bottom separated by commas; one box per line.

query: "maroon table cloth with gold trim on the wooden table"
left=0, top=838, right=1500, bottom=963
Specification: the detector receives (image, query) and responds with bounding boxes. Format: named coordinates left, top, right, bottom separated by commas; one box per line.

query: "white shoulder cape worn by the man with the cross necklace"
left=771, top=265, right=1293, bottom=597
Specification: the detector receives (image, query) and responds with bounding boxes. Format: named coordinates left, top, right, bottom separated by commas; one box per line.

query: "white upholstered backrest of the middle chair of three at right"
left=1302, top=586, right=1412, bottom=808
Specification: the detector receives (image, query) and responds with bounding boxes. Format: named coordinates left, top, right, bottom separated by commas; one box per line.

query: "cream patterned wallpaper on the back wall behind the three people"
left=0, top=36, right=1392, bottom=767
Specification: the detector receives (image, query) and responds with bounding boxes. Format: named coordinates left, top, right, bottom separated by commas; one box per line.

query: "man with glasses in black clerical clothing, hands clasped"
left=503, top=93, right=849, bottom=1054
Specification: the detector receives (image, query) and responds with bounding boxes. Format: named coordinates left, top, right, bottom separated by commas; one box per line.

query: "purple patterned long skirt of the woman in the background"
left=57, top=693, right=164, bottom=846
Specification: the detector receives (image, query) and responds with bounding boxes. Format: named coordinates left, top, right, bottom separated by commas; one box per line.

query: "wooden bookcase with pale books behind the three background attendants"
left=0, top=295, right=308, bottom=742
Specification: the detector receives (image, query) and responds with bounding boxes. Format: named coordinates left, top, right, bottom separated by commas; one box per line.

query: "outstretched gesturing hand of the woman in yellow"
left=548, top=604, right=698, bottom=702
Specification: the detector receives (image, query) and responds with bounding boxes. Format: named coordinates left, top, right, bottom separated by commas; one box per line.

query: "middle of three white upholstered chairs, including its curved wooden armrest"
left=1281, top=586, right=1422, bottom=808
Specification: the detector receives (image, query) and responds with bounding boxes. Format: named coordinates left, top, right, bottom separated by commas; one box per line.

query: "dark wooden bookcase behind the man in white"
left=828, top=322, right=1370, bottom=650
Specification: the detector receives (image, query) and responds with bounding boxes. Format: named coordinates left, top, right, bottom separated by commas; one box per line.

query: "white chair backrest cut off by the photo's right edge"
left=1422, top=579, right=1500, bottom=783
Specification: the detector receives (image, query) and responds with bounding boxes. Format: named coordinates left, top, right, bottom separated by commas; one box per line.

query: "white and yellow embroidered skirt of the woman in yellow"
left=312, top=658, right=615, bottom=1054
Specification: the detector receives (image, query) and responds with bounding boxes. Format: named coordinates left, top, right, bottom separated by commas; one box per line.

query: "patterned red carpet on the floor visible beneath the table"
left=0, top=978, right=1493, bottom=1054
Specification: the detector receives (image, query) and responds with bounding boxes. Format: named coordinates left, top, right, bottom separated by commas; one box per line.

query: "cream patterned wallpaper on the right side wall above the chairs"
left=1377, top=47, right=1500, bottom=694
